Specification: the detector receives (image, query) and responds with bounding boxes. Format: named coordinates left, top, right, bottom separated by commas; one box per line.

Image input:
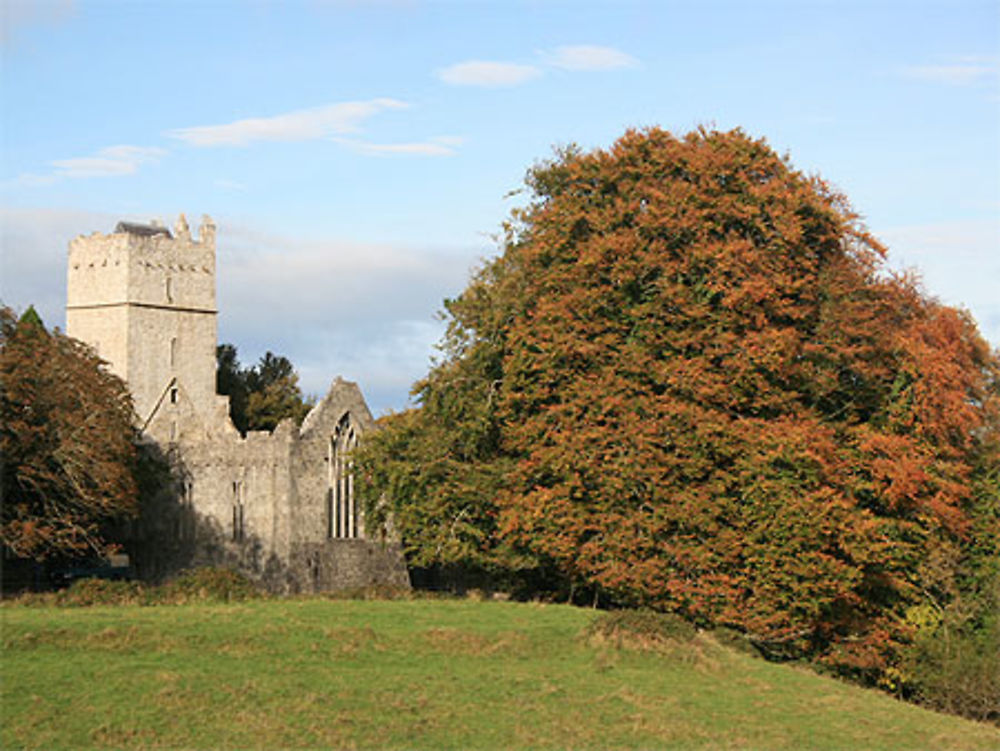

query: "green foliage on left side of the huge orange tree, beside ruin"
left=355, top=250, right=524, bottom=576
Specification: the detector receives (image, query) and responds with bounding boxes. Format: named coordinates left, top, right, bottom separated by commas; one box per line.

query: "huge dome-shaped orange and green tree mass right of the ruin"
left=359, top=129, right=1000, bottom=688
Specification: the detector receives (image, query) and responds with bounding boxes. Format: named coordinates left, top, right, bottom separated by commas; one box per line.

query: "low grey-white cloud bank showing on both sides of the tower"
left=0, top=208, right=484, bottom=414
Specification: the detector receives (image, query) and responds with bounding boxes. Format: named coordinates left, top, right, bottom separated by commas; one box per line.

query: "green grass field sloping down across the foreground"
left=0, top=599, right=1000, bottom=751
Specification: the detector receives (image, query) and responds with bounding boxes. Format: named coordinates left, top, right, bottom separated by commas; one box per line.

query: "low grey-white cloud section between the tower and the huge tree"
left=217, top=219, right=483, bottom=413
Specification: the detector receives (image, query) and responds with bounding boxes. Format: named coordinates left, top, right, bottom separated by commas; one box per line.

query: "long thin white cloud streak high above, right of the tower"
left=167, top=98, right=409, bottom=146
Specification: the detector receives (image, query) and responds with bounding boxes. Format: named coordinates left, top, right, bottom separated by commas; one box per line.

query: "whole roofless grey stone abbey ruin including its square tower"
left=66, top=215, right=409, bottom=592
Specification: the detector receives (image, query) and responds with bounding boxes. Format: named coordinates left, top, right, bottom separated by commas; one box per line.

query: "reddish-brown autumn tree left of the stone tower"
left=0, top=308, right=138, bottom=561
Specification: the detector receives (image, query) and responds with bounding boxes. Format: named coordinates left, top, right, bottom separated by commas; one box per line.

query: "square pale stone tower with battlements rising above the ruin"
left=66, top=214, right=217, bottom=426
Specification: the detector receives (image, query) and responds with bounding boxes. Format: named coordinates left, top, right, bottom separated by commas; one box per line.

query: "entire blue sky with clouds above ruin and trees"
left=0, top=0, right=1000, bottom=413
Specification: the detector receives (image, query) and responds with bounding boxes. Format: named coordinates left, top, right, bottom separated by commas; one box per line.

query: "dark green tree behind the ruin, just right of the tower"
left=216, top=344, right=313, bottom=433
